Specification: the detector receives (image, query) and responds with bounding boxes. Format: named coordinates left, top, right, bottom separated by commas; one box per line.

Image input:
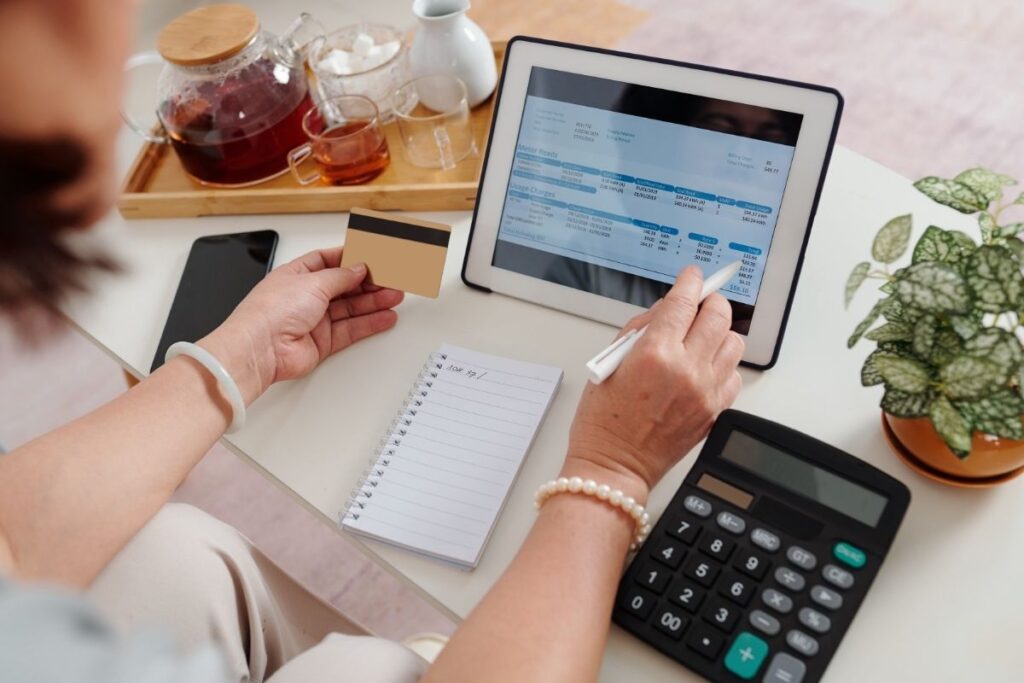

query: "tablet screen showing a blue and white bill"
left=493, top=67, right=803, bottom=333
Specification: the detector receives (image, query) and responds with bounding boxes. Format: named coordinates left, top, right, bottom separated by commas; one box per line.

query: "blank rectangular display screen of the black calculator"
left=722, top=431, right=889, bottom=526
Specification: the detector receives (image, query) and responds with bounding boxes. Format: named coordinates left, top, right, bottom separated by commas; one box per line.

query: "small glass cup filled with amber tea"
left=288, top=95, right=391, bottom=185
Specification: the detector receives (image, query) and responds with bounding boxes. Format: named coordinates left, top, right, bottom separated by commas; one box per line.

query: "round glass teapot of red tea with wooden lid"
left=124, top=4, right=325, bottom=186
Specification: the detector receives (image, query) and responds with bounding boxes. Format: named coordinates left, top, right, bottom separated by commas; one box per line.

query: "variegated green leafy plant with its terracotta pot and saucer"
left=846, top=168, right=1024, bottom=485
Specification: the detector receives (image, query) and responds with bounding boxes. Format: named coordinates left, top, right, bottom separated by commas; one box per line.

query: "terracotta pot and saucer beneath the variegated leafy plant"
left=883, top=413, right=1024, bottom=486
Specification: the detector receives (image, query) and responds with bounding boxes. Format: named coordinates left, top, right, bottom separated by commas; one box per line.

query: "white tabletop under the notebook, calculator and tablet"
left=66, top=126, right=1024, bottom=682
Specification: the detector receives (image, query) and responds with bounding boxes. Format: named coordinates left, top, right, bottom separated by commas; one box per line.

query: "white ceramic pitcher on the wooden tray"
left=409, top=0, right=498, bottom=106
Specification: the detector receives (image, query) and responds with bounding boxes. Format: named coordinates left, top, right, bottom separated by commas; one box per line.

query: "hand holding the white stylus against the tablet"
left=563, top=266, right=744, bottom=501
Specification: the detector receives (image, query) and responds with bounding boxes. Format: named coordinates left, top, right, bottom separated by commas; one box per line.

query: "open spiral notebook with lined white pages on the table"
left=341, top=344, right=562, bottom=569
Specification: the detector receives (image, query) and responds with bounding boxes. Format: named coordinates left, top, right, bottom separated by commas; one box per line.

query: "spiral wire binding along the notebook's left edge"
left=338, top=352, right=447, bottom=523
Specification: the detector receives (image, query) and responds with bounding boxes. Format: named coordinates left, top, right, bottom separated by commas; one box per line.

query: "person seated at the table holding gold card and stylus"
left=0, top=0, right=743, bottom=683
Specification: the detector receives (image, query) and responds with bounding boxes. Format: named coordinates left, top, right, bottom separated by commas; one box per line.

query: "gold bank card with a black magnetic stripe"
left=341, top=209, right=452, bottom=299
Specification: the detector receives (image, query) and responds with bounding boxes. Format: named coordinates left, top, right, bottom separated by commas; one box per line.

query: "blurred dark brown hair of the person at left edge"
left=0, top=137, right=113, bottom=312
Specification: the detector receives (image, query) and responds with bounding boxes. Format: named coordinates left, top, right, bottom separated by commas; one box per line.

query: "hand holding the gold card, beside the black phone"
left=200, top=247, right=403, bottom=403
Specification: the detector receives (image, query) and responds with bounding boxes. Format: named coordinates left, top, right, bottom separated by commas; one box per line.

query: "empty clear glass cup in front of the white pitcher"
left=394, top=74, right=476, bottom=169
